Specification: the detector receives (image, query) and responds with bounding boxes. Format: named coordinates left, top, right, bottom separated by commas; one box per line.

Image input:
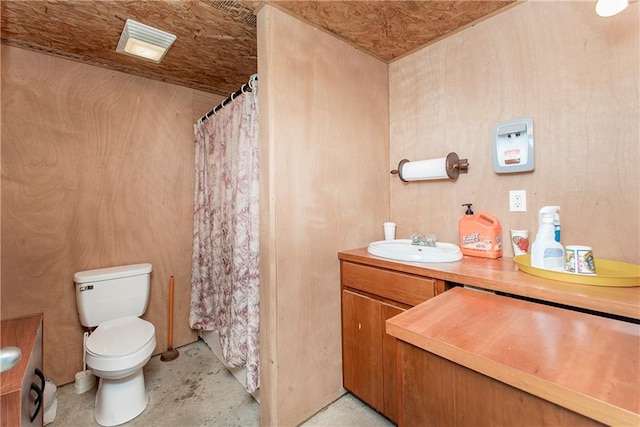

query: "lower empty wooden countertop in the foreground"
left=386, top=288, right=640, bottom=425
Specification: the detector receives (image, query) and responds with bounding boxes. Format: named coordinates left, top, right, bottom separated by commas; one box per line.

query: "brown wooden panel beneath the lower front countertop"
left=398, top=340, right=603, bottom=427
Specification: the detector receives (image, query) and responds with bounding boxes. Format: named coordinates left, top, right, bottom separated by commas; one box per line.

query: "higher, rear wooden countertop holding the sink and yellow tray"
left=338, top=248, right=640, bottom=319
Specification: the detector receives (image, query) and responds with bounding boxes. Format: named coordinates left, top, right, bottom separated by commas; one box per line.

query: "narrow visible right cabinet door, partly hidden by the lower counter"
left=382, top=304, right=404, bottom=423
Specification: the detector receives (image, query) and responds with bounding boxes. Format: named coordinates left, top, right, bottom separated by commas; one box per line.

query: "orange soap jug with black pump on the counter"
left=459, top=203, right=502, bottom=258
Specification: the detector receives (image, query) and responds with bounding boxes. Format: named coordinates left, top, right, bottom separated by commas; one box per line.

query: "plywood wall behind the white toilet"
left=1, top=46, right=221, bottom=385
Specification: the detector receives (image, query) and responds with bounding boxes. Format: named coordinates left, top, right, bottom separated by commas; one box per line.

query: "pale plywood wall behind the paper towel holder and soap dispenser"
left=388, top=2, right=640, bottom=263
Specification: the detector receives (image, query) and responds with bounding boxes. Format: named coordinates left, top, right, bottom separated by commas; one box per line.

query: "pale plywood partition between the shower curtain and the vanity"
left=258, top=6, right=389, bottom=426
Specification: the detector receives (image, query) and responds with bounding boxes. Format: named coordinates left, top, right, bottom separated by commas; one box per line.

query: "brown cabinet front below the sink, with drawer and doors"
left=340, top=260, right=445, bottom=422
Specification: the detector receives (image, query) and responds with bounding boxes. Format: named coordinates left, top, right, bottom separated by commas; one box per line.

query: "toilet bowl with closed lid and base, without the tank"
left=86, top=317, right=156, bottom=426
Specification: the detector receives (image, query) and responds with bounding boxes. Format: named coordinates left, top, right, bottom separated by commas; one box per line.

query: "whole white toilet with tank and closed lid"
left=73, top=264, right=156, bottom=426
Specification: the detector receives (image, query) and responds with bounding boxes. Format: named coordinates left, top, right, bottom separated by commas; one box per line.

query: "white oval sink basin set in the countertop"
left=367, top=239, right=462, bottom=262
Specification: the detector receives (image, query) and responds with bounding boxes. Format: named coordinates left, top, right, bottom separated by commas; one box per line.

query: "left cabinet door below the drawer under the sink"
left=342, top=291, right=384, bottom=412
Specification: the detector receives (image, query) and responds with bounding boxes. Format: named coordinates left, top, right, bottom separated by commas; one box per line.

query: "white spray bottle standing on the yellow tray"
left=531, top=206, right=564, bottom=271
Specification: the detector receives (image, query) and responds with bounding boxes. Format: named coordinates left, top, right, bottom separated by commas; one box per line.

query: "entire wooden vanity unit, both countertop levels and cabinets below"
left=338, top=247, right=640, bottom=426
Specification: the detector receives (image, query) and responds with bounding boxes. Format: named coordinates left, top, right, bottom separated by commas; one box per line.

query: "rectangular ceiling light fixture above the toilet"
left=116, top=19, right=177, bottom=62
